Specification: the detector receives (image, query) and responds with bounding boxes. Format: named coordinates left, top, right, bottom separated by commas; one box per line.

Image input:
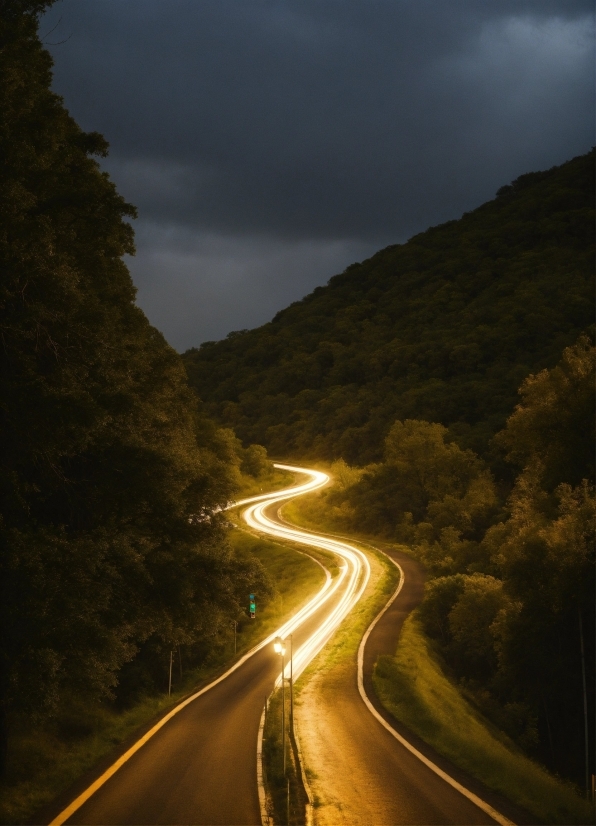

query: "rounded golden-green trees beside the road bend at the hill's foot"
left=296, top=419, right=498, bottom=573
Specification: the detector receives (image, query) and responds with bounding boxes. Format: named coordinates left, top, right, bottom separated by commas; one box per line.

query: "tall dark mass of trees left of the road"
left=0, top=0, right=266, bottom=772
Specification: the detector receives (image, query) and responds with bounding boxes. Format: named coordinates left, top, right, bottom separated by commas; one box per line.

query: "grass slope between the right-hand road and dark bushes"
left=373, top=613, right=594, bottom=824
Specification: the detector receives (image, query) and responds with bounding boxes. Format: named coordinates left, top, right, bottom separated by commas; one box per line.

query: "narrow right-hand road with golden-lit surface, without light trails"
left=297, top=536, right=536, bottom=826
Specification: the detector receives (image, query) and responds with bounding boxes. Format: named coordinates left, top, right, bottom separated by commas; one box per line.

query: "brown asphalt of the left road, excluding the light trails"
left=47, top=470, right=349, bottom=826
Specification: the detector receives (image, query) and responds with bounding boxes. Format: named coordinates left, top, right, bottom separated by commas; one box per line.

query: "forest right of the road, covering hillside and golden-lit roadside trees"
left=184, top=146, right=595, bottom=788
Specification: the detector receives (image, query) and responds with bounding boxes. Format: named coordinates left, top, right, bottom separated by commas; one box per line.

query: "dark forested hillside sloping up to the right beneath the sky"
left=184, top=152, right=594, bottom=464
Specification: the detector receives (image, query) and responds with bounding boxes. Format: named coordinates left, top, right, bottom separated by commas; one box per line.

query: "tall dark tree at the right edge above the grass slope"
left=483, top=336, right=596, bottom=779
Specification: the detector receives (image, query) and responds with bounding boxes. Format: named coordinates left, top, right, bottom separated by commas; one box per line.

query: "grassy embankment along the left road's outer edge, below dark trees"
left=0, top=474, right=324, bottom=824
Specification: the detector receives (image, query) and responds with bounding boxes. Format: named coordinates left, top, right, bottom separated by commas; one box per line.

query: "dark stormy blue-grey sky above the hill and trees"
left=39, top=0, right=595, bottom=351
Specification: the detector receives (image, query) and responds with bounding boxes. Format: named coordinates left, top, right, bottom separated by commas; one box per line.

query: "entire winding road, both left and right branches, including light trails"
left=45, top=465, right=520, bottom=826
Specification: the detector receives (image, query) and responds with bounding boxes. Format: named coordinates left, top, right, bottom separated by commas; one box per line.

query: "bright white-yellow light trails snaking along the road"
left=234, top=464, right=370, bottom=684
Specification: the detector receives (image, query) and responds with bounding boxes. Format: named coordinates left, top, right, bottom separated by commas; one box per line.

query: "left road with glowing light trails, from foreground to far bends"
left=46, top=467, right=368, bottom=826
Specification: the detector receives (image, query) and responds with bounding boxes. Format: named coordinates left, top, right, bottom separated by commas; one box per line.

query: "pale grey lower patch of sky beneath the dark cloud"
left=129, top=224, right=374, bottom=349
